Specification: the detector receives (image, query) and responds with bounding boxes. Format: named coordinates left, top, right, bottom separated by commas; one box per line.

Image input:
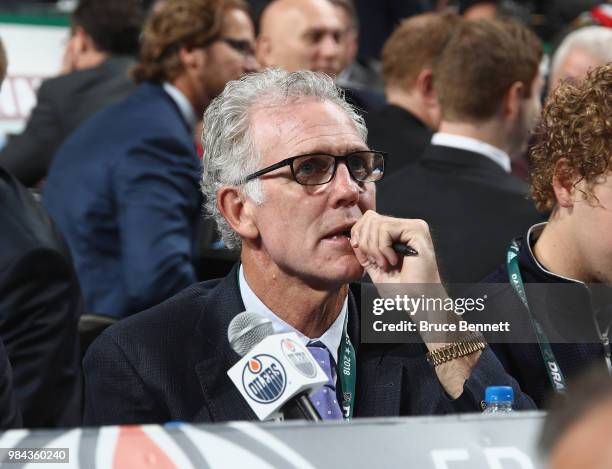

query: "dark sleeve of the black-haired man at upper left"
left=0, top=81, right=65, bottom=187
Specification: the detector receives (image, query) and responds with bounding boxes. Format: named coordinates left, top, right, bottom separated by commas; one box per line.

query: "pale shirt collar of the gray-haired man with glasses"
left=238, top=264, right=348, bottom=363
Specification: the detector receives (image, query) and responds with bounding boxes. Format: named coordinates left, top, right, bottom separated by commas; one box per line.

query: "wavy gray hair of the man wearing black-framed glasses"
left=201, top=69, right=367, bottom=249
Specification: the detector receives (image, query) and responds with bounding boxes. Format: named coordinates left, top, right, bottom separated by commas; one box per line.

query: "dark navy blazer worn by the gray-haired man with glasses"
left=84, top=267, right=533, bottom=425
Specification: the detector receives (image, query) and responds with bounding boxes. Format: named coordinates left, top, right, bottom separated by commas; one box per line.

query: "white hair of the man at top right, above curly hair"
left=551, top=26, right=612, bottom=80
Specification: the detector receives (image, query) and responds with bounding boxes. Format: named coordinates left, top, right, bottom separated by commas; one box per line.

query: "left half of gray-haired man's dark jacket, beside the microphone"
left=84, top=268, right=255, bottom=425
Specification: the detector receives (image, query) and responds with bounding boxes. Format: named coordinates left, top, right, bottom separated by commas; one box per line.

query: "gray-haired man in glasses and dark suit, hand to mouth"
left=84, top=70, right=530, bottom=425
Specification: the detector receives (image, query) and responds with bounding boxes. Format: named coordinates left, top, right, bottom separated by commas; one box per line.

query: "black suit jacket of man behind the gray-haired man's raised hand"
left=378, top=145, right=542, bottom=284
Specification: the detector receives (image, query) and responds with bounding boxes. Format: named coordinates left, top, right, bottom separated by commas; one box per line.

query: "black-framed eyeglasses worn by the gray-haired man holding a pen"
left=245, top=150, right=387, bottom=186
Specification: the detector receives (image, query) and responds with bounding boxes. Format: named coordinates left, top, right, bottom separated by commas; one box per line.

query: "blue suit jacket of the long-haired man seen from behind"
left=43, top=83, right=201, bottom=317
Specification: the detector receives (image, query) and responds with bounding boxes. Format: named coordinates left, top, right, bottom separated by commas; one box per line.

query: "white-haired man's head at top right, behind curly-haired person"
left=550, top=26, right=612, bottom=89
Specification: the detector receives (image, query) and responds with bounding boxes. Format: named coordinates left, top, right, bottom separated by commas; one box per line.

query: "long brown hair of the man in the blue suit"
left=132, top=0, right=249, bottom=83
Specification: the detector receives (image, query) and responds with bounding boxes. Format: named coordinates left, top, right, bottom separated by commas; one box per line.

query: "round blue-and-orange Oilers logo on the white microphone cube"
left=242, top=354, right=287, bottom=404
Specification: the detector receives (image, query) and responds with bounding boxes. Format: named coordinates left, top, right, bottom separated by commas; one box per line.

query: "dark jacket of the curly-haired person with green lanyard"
left=483, top=229, right=606, bottom=407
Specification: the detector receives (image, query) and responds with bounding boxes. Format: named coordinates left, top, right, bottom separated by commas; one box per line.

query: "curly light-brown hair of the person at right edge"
left=530, top=62, right=612, bottom=211
